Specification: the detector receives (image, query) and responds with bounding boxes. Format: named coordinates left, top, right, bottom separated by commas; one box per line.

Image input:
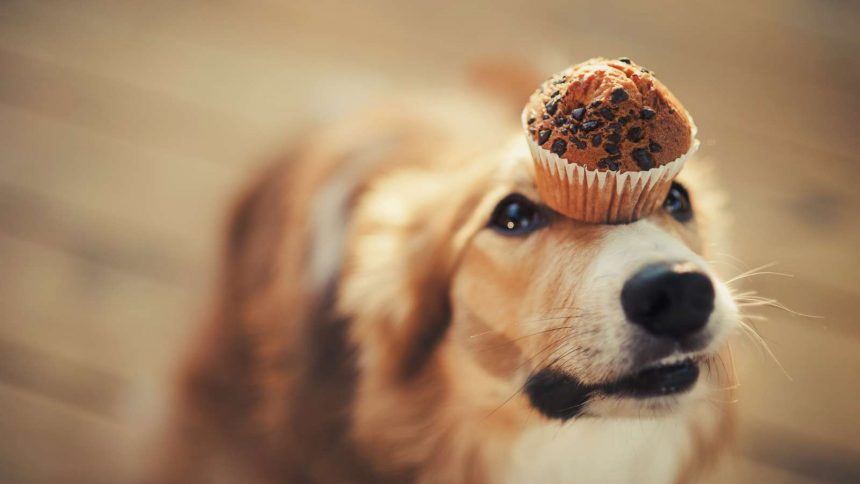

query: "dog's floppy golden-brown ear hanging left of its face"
left=339, top=171, right=490, bottom=378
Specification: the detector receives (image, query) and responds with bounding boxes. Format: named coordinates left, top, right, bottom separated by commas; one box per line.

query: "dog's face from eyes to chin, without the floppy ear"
left=451, top=142, right=737, bottom=419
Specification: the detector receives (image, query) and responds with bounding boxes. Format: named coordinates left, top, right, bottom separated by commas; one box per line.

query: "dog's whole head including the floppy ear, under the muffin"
left=341, top=130, right=737, bottom=466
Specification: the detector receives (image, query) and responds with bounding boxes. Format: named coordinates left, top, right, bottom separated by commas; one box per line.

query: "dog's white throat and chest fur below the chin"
left=499, top=394, right=720, bottom=484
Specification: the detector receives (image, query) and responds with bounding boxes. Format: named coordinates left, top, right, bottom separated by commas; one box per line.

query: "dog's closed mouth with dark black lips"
left=525, top=356, right=699, bottom=420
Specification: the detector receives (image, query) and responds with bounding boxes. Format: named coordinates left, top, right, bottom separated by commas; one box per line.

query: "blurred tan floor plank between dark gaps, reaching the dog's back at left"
left=0, top=105, right=239, bottom=270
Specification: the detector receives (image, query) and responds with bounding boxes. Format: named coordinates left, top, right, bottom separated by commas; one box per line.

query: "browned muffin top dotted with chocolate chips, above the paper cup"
left=523, top=57, right=693, bottom=172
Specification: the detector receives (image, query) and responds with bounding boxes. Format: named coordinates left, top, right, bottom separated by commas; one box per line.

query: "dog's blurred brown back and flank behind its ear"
left=156, top=96, right=510, bottom=483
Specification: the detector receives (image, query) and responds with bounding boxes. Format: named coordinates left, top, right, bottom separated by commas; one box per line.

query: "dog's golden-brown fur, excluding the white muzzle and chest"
left=155, top=85, right=730, bottom=483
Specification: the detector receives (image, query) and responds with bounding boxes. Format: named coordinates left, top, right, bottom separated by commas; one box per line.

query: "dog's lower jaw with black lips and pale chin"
left=525, top=354, right=704, bottom=420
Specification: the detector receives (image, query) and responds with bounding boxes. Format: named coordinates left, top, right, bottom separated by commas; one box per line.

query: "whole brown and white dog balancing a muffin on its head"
left=159, top=87, right=738, bottom=483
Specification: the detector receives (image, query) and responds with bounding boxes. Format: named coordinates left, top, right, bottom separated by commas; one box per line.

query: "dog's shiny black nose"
left=621, top=262, right=714, bottom=339
